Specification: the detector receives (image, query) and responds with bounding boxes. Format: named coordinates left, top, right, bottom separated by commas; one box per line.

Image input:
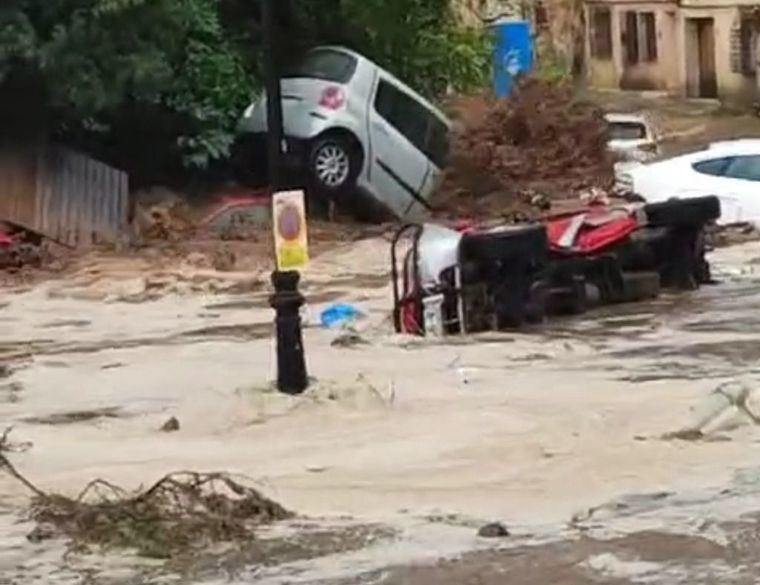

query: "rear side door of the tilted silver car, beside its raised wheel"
left=369, top=73, right=431, bottom=217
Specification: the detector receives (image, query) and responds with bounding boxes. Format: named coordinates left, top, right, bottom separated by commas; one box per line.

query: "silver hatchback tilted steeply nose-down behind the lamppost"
left=239, top=47, right=450, bottom=218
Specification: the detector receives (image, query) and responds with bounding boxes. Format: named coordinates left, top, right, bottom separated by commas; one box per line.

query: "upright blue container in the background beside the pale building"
left=493, top=20, right=533, bottom=97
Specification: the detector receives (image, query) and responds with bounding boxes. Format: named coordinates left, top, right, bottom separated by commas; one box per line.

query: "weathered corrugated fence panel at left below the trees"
left=0, top=147, right=129, bottom=246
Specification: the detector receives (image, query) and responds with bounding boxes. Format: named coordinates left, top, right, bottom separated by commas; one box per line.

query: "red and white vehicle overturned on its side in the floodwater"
left=391, top=197, right=720, bottom=335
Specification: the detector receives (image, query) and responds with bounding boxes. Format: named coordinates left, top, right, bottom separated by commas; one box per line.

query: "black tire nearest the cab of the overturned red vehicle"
left=460, top=225, right=549, bottom=264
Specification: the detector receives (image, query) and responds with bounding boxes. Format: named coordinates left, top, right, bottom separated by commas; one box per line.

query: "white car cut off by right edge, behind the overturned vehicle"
left=617, top=139, right=760, bottom=224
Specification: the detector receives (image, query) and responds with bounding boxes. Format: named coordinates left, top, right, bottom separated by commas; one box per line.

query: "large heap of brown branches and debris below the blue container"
left=434, top=78, right=614, bottom=221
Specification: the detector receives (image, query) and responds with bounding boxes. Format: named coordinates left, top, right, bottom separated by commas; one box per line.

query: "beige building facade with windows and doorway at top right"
left=585, top=0, right=758, bottom=103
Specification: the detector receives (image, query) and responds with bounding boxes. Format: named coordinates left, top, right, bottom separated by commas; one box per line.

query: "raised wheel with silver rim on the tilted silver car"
left=308, top=136, right=362, bottom=198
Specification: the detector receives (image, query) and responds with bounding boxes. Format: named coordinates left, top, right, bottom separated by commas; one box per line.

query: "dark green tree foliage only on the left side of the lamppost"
left=0, top=0, right=252, bottom=172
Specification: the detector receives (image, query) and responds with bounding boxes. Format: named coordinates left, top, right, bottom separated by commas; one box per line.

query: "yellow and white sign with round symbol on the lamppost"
left=272, top=191, right=309, bottom=271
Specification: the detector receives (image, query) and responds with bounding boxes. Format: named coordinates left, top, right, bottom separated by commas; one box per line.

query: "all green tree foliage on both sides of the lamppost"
left=0, top=0, right=490, bottom=176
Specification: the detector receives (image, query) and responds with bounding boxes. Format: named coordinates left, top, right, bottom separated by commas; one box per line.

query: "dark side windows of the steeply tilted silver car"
left=375, top=79, right=449, bottom=168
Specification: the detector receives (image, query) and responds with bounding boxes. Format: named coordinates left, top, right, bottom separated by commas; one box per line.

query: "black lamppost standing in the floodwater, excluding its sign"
left=261, top=0, right=309, bottom=394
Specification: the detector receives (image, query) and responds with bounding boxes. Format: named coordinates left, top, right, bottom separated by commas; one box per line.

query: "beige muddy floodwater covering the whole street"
left=0, top=239, right=760, bottom=585
